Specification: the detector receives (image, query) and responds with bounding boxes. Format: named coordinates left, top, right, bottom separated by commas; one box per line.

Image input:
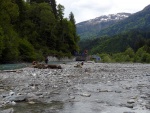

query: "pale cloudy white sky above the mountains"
left=56, top=0, right=150, bottom=23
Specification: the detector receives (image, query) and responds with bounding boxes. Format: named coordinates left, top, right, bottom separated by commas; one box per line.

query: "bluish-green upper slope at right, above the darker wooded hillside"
left=97, top=5, right=150, bottom=37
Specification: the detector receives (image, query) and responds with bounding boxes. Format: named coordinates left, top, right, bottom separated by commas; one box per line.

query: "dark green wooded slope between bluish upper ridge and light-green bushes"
left=80, top=28, right=150, bottom=54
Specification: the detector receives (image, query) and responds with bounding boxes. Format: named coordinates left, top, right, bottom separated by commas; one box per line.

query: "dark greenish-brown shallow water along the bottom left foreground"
left=1, top=101, right=63, bottom=113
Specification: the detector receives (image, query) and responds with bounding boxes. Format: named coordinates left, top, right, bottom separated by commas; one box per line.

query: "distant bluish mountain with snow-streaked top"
left=76, top=13, right=131, bottom=40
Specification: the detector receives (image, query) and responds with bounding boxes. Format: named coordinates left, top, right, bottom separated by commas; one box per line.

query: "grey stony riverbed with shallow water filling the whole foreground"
left=0, top=62, right=150, bottom=113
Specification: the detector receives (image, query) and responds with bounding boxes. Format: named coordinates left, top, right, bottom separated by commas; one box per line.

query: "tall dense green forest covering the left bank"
left=0, top=0, right=79, bottom=63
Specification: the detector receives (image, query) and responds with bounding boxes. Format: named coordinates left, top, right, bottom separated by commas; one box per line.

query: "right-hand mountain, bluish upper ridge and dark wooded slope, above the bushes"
left=79, top=5, right=150, bottom=54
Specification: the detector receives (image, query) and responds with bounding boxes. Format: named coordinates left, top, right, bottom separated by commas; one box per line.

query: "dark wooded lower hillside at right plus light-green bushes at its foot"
left=80, top=29, right=150, bottom=63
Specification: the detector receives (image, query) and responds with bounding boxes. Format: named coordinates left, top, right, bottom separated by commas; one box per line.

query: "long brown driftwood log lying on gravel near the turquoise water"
left=32, top=61, right=62, bottom=69
